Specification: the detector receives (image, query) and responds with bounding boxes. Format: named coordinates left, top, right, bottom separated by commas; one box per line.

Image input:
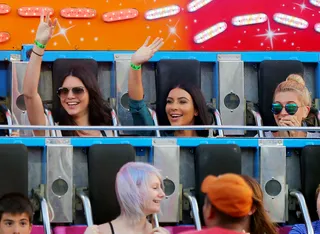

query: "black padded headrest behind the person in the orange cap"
left=195, top=144, right=241, bottom=223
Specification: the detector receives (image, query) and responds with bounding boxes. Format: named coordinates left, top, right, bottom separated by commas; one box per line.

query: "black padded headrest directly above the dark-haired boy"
left=0, top=144, right=28, bottom=196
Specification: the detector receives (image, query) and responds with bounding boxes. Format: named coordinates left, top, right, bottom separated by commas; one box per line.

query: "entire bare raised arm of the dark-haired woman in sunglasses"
left=23, top=12, right=57, bottom=136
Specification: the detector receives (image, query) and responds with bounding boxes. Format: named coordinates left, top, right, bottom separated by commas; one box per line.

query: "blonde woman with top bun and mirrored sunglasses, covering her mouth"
left=265, top=74, right=319, bottom=138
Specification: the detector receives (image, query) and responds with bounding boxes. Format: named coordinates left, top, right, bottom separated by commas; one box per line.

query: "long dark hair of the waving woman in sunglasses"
left=56, top=66, right=112, bottom=136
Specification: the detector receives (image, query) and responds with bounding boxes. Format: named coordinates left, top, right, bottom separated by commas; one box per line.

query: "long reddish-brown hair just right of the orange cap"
left=241, top=175, right=278, bottom=234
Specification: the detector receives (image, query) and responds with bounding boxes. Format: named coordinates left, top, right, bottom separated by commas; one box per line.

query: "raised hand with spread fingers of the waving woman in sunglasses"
left=36, top=10, right=57, bottom=45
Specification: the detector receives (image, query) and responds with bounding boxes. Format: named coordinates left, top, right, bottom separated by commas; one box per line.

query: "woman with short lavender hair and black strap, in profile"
left=85, top=162, right=169, bottom=234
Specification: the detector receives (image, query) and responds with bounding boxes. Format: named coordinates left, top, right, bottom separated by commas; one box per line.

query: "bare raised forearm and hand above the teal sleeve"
left=128, top=37, right=163, bottom=101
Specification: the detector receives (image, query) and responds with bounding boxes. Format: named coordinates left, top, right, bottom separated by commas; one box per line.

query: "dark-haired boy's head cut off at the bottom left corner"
left=0, top=193, right=33, bottom=234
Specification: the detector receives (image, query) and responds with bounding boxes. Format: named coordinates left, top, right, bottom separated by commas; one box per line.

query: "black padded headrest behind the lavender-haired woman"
left=88, top=144, right=136, bottom=224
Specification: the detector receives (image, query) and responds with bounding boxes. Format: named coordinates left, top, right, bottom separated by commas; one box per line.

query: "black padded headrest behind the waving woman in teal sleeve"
left=156, top=59, right=201, bottom=125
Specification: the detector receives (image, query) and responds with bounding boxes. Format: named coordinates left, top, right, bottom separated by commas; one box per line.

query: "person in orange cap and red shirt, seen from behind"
left=183, top=174, right=254, bottom=234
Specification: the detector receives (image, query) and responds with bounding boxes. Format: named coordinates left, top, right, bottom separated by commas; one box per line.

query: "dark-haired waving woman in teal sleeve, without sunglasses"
left=128, top=37, right=211, bottom=137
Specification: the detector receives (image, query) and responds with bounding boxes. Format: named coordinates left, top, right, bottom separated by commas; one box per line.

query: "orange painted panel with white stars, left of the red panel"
left=0, top=0, right=190, bottom=50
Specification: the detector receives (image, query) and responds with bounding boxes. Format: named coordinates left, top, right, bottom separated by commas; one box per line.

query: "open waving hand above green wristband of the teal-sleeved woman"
left=131, top=37, right=164, bottom=65
